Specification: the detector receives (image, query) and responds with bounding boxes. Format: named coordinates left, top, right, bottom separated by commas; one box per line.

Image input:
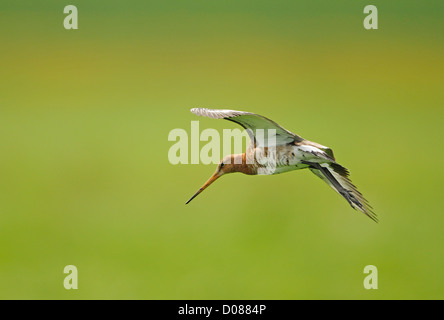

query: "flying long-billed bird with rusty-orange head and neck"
left=186, top=108, right=378, bottom=222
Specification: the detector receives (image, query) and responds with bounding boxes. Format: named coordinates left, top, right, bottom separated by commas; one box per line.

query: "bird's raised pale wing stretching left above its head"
left=191, top=108, right=304, bottom=147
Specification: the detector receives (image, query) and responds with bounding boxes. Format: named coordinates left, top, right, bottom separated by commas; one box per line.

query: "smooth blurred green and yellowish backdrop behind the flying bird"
left=0, top=0, right=444, bottom=299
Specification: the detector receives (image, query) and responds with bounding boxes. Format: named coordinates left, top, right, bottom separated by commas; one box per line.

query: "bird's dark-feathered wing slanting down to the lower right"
left=310, top=163, right=378, bottom=222
